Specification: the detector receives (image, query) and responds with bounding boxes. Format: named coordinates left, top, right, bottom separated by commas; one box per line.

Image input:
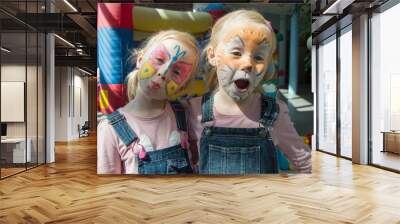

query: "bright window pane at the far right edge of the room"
left=370, top=1, right=400, bottom=170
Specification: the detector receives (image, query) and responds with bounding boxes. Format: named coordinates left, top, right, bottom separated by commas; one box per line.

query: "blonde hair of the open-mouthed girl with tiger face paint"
left=202, top=9, right=276, bottom=91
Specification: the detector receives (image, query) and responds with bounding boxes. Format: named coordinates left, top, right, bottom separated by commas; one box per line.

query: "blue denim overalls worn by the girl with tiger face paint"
left=199, top=93, right=279, bottom=174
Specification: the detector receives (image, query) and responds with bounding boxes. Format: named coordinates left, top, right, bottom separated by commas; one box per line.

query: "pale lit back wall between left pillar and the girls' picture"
left=55, top=67, right=88, bottom=141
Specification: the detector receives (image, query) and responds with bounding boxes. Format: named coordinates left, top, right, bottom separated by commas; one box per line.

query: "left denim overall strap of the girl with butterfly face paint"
left=106, top=110, right=137, bottom=146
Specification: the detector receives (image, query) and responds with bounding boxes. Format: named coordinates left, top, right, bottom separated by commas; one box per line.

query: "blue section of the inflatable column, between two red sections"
left=97, top=28, right=134, bottom=84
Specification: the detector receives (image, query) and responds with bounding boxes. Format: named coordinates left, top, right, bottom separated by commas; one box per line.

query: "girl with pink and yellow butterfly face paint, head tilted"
left=97, top=30, right=199, bottom=174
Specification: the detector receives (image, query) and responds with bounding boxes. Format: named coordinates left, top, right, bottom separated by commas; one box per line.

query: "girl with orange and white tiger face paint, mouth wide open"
left=189, top=10, right=311, bottom=174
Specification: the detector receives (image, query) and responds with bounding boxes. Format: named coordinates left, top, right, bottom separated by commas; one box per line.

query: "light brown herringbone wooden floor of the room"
left=0, top=134, right=400, bottom=224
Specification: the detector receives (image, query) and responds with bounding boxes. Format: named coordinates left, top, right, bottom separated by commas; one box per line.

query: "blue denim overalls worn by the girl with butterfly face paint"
left=107, top=102, right=193, bottom=174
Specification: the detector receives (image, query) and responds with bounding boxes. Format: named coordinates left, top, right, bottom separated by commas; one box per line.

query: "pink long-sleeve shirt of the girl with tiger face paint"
left=187, top=94, right=311, bottom=173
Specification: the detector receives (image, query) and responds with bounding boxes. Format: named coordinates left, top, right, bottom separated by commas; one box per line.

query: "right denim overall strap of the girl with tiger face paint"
left=260, top=95, right=279, bottom=127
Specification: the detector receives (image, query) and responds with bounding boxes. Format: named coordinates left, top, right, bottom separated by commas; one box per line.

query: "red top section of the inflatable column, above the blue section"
left=97, top=3, right=134, bottom=29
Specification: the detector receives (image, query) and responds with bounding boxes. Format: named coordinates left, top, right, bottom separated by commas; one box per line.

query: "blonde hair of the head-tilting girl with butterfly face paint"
left=127, top=30, right=200, bottom=101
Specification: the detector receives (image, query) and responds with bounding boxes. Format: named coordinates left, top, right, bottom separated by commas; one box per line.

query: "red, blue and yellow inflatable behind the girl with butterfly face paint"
left=97, top=3, right=222, bottom=114
